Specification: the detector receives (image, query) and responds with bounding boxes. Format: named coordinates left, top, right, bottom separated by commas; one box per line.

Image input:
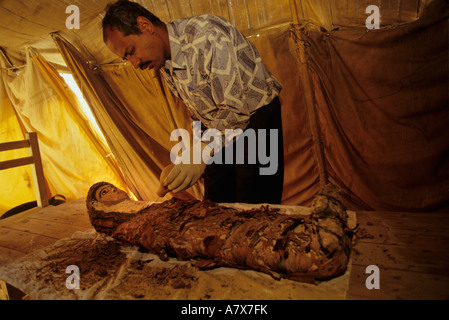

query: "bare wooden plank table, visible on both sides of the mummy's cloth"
left=0, top=199, right=449, bottom=300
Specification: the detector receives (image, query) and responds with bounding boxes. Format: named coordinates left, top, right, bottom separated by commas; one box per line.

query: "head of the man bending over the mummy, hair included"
left=102, top=0, right=170, bottom=70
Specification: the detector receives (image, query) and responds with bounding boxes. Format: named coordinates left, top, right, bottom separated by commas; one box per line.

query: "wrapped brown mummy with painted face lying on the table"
left=86, top=182, right=353, bottom=283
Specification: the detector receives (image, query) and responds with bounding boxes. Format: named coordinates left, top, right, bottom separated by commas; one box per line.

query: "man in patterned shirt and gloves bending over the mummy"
left=102, top=1, right=283, bottom=203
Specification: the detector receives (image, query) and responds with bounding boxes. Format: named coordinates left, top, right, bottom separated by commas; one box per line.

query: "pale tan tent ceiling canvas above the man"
left=0, top=0, right=430, bottom=68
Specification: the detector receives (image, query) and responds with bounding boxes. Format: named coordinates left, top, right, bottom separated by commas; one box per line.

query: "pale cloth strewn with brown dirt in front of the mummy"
left=0, top=205, right=351, bottom=300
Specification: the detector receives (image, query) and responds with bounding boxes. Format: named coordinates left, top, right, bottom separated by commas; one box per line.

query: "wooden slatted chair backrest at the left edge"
left=0, top=132, right=48, bottom=207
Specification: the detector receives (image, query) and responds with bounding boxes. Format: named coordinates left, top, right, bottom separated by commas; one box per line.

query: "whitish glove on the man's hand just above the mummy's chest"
left=163, top=143, right=207, bottom=193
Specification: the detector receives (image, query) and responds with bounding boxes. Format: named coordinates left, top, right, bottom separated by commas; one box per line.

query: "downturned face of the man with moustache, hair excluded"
left=106, top=19, right=168, bottom=70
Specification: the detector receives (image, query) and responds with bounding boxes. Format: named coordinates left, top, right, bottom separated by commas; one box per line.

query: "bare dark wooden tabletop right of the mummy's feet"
left=347, top=211, right=449, bottom=299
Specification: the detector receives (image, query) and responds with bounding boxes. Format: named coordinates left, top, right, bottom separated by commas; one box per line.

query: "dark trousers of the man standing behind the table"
left=204, top=98, right=284, bottom=204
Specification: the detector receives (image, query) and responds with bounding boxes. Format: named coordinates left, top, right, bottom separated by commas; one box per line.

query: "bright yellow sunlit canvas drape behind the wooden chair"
left=0, top=49, right=125, bottom=215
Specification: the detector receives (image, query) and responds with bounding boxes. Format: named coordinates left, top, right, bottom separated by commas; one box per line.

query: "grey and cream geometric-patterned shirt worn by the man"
left=161, top=14, right=282, bottom=132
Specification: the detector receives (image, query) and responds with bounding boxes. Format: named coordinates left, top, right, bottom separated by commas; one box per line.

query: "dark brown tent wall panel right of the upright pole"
left=300, top=2, right=449, bottom=211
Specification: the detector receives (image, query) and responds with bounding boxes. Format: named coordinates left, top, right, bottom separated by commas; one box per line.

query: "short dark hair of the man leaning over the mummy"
left=101, top=0, right=165, bottom=41
